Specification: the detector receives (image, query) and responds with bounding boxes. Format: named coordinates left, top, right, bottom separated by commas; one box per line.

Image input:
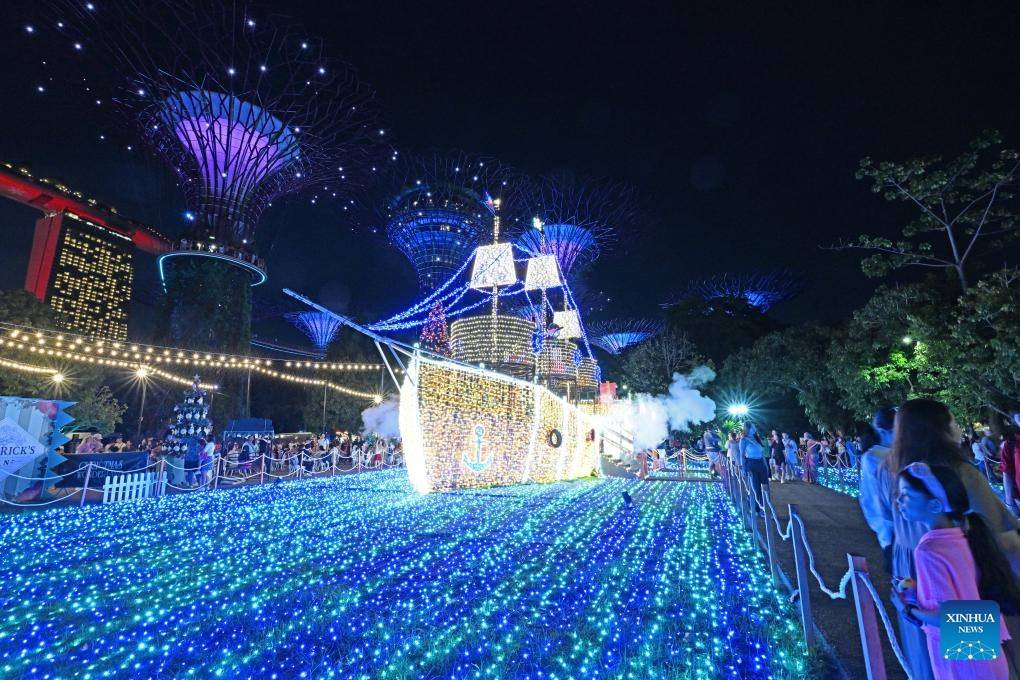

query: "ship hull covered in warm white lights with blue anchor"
left=400, top=357, right=601, bottom=493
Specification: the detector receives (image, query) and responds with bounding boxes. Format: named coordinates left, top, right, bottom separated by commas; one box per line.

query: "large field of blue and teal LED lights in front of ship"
left=0, top=471, right=806, bottom=679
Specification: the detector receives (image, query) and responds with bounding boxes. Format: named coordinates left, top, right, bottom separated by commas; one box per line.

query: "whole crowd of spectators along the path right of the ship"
left=652, top=399, right=1020, bottom=680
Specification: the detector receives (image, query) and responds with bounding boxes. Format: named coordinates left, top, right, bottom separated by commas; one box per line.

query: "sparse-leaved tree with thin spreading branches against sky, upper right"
left=834, top=132, right=1020, bottom=293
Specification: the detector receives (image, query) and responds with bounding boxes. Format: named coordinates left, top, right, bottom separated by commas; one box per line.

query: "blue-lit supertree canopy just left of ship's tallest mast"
left=384, top=152, right=514, bottom=293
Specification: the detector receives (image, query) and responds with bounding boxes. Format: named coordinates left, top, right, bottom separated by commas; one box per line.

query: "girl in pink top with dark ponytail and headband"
left=893, top=463, right=1020, bottom=680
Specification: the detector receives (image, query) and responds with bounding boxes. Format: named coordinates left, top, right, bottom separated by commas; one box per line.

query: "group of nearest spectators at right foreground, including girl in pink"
left=861, top=399, right=1020, bottom=680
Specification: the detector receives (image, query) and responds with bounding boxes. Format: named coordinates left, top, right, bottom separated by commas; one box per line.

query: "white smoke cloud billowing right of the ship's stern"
left=624, top=366, right=715, bottom=451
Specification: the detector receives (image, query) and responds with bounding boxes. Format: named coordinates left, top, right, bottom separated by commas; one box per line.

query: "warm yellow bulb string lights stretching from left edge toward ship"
left=0, top=323, right=384, bottom=403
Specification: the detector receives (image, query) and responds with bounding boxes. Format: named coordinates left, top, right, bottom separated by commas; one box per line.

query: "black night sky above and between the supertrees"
left=0, top=0, right=1020, bottom=344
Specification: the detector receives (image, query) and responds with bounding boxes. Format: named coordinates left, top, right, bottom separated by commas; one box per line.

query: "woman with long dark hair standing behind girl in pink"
left=878, top=399, right=1020, bottom=680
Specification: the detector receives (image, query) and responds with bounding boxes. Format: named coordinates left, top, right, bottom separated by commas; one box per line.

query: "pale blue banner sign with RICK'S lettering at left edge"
left=0, top=397, right=73, bottom=503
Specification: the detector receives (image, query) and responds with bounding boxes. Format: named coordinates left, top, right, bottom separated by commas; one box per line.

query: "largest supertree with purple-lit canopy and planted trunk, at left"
left=34, top=0, right=383, bottom=350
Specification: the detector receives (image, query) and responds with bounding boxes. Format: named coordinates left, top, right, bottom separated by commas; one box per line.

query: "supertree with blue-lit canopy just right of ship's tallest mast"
left=515, top=174, right=634, bottom=276
